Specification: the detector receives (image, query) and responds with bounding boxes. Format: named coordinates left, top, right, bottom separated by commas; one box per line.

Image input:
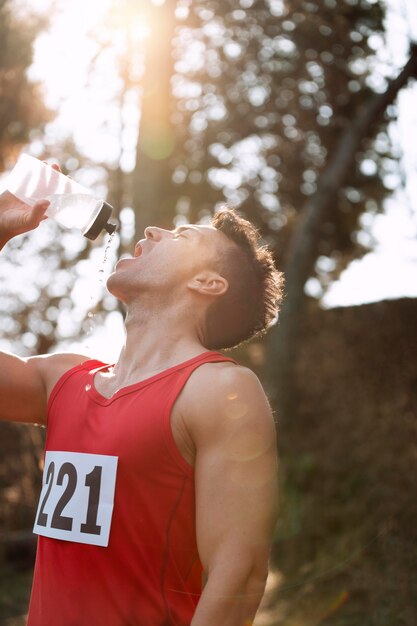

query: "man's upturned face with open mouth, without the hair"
left=107, top=224, right=230, bottom=302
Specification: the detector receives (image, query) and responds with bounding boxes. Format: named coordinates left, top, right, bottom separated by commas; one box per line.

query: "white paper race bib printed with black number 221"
left=33, top=451, right=117, bottom=546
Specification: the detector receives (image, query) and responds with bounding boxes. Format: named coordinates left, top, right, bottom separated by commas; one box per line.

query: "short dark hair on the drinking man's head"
left=205, top=208, right=284, bottom=350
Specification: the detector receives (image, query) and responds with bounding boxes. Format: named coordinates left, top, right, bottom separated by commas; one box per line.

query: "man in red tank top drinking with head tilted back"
left=0, top=172, right=282, bottom=626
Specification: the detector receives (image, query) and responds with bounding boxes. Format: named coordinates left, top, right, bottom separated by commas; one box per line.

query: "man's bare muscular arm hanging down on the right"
left=184, top=364, right=277, bottom=626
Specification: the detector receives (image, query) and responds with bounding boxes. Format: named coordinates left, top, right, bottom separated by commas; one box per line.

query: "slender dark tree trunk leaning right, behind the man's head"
left=266, top=45, right=417, bottom=416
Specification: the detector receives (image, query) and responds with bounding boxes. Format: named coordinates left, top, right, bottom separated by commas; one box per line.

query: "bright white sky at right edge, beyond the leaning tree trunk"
left=322, top=0, right=417, bottom=307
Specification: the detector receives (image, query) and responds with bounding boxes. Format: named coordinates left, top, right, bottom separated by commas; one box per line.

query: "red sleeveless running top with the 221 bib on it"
left=28, top=352, right=236, bottom=626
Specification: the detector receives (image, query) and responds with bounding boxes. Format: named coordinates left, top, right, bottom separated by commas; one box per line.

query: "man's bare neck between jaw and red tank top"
left=109, top=296, right=205, bottom=382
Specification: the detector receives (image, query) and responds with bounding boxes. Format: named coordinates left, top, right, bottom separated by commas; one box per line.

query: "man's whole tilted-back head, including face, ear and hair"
left=108, top=210, right=283, bottom=349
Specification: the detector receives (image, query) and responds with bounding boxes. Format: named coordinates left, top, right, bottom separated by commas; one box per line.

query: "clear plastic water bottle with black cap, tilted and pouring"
left=7, top=154, right=116, bottom=239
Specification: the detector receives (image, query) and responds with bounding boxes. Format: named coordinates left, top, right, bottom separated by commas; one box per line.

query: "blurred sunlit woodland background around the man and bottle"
left=0, top=0, right=417, bottom=626
